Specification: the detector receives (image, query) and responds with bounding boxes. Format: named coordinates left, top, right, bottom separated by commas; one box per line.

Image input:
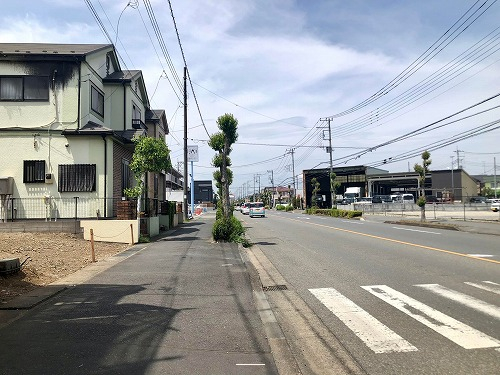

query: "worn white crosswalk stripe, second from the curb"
left=362, top=285, right=500, bottom=349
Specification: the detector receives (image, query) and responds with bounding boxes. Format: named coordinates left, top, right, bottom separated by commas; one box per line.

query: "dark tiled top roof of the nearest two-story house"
left=0, top=43, right=111, bottom=56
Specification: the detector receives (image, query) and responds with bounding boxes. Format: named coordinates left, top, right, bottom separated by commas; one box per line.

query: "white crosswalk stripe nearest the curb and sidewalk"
left=309, top=288, right=418, bottom=353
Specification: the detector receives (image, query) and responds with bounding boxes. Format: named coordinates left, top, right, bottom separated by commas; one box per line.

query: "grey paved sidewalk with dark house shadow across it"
left=0, top=212, right=278, bottom=374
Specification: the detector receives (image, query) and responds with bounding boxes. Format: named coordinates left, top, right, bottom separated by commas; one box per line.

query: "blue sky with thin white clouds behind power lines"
left=0, top=0, right=500, bottom=196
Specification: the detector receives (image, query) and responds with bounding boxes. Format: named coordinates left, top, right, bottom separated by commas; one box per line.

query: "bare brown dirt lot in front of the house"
left=0, top=233, right=130, bottom=303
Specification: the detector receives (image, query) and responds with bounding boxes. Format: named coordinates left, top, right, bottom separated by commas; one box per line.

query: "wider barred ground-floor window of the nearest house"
left=58, top=164, right=96, bottom=192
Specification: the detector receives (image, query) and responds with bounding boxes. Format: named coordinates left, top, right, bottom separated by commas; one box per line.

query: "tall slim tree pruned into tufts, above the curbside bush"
left=208, top=113, right=238, bottom=220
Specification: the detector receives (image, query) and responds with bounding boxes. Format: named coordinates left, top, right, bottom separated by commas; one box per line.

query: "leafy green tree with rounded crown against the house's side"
left=123, top=136, right=172, bottom=213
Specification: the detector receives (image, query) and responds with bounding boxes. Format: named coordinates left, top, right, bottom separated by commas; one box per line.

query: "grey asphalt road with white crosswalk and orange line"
left=237, top=211, right=500, bottom=375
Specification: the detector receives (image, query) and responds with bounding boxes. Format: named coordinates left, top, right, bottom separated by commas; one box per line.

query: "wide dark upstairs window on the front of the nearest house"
left=0, top=76, right=49, bottom=101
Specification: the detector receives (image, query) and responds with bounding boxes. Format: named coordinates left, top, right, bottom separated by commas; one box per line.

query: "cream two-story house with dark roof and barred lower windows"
left=0, top=43, right=168, bottom=219
